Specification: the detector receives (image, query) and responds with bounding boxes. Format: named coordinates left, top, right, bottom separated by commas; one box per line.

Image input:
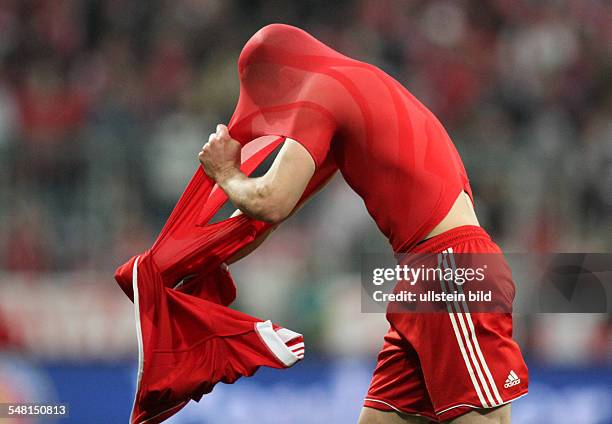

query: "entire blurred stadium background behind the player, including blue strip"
left=0, top=0, right=612, bottom=424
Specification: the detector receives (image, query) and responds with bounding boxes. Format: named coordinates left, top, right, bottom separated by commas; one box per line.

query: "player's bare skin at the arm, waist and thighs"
left=198, top=124, right=510, bottom=424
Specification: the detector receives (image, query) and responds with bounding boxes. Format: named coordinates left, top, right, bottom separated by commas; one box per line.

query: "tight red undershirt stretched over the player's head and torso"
left=229, top=24, right=471, bottom=251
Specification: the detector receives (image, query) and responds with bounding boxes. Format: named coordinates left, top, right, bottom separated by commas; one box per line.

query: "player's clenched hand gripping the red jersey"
left=198, top=124, right=241, bottom=183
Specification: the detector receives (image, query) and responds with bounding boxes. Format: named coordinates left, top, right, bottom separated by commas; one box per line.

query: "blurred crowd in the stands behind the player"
left=0, top=0, right=612, bottom=357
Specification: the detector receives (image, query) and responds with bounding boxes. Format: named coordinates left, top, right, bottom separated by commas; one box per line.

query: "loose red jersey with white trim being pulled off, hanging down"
left=115, top=137, right=333, bottom=423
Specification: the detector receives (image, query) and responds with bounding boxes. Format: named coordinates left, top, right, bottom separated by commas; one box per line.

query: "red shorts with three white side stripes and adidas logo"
left=364, top=226, right=528, bottom=422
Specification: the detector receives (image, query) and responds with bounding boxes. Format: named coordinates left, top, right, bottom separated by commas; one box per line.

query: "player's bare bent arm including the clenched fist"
left=199, top=125, right=315, bottom=224
